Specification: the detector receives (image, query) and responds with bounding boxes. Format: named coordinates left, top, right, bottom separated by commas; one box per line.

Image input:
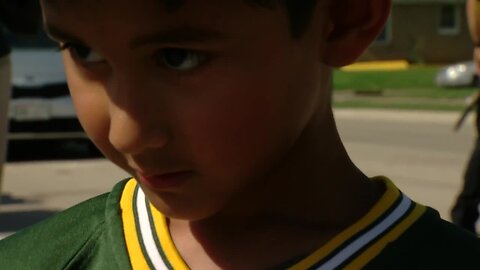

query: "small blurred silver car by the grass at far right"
left=435, top=61, right=478, bottom=87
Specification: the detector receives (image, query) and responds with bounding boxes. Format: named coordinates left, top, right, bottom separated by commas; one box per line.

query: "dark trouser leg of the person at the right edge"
left=451, top=139, right=480, bottom=233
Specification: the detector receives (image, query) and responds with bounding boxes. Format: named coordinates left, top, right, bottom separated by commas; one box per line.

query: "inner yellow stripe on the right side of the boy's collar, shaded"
left=289, top=178, right=400, bottom=270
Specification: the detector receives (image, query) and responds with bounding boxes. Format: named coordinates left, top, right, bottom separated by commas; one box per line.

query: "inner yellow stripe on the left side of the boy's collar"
left=150, top=204, right=190, bottom=270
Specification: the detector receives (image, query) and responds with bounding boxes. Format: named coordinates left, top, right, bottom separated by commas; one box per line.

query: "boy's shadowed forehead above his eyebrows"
left=40, top=0, right=228, bottom=33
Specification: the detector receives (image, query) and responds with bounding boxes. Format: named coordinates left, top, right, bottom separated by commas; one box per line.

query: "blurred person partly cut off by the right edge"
left=451, top=0, right=480, bottom=233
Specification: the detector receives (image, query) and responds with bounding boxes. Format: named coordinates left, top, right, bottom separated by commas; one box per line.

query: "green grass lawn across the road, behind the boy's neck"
left=334, top=66, right=476, bottom=110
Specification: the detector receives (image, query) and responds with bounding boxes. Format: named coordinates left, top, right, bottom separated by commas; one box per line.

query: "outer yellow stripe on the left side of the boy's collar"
left=120, top=179, right=150, bottom=270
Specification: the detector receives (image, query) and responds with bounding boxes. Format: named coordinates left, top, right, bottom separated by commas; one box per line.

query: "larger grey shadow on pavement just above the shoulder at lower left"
left=0, top=210, right=58, bottom=232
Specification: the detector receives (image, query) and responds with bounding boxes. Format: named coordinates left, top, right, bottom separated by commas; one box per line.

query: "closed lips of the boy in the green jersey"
left=137, top=171, right=193, bottom=191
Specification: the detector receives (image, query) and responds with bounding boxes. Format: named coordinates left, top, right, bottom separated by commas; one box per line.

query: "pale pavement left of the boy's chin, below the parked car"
left=0, top=159, right=127, bottom=238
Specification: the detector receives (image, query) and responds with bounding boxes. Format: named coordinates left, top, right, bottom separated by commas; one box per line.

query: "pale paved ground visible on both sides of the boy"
left=0, top=109, right=474, bottom=237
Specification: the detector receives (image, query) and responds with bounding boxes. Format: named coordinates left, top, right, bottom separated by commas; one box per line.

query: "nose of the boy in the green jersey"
left=107, top=77, right=168, bottom=154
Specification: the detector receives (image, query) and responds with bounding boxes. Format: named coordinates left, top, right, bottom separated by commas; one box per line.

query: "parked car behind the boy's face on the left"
left=8, top=33, right=86, bottom=141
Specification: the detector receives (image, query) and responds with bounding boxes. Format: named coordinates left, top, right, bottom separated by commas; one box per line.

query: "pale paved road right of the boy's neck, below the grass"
left=336, top=110, right=475, bottom=219
